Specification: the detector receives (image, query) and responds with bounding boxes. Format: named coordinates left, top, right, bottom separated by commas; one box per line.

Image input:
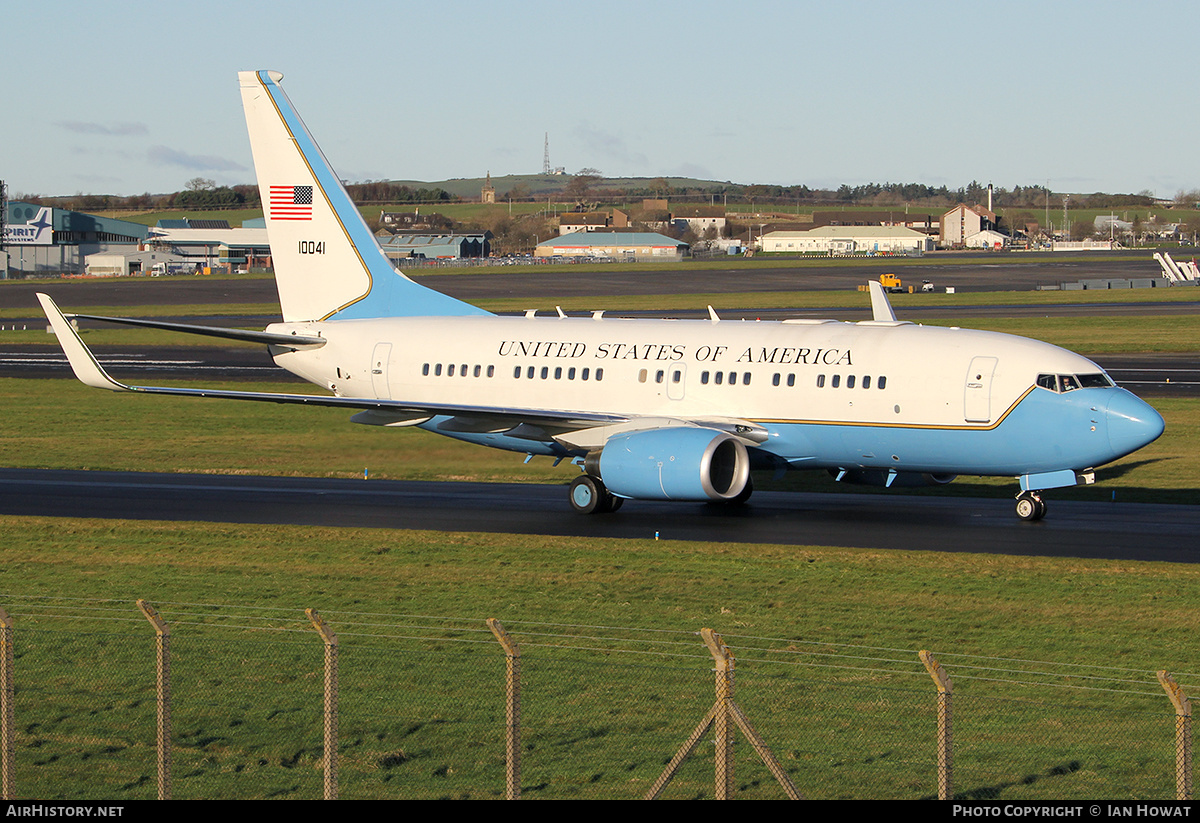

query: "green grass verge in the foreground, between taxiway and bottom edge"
left=0, top=517, right=1200, bottom=800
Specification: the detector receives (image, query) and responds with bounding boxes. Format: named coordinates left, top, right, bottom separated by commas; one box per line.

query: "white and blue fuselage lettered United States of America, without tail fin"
left=269, top=317, right=1163, bottom=488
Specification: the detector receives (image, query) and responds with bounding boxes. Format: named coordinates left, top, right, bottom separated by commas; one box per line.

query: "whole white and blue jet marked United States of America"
left=40, top=71, right=1163, bottom=519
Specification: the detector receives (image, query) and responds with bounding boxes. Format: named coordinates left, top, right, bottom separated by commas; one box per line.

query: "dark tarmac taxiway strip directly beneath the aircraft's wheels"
left=0, top=469, right=1200, bottom=563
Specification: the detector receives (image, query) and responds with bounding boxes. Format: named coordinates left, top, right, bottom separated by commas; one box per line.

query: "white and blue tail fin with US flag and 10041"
left=238, top=71, right=487, bottom=322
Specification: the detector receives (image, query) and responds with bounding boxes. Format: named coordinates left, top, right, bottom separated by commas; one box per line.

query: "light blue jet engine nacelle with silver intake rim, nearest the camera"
left=588, top=427, right=750, bottom=501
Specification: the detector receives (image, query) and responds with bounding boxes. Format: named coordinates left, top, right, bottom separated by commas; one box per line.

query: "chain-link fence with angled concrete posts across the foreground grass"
left=0, top=599, right=1192, bottom=800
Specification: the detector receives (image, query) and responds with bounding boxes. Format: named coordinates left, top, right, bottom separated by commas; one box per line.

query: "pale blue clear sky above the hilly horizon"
left=0, top=0, right=1200, bottom=197
